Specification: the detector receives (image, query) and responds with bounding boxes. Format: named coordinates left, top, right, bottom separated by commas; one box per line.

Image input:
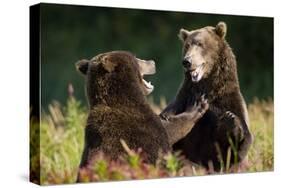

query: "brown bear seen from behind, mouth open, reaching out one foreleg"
left=77, top=51, right=208, bottom=181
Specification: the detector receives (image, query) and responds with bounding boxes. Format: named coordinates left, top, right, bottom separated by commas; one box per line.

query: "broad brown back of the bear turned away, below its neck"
left=87, top=105, right=170, bottom=162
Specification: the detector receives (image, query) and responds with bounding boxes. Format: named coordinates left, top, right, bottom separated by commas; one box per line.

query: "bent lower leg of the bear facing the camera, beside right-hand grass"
left=216, top=111, right=252, bottom=163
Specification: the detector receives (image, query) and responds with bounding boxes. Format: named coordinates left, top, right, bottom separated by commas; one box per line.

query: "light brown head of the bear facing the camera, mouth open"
left=178, top=22, right=226, bottom=82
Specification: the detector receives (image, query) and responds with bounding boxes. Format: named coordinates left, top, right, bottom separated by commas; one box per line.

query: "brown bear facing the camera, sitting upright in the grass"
left=160, top=22, right=252, bottom=171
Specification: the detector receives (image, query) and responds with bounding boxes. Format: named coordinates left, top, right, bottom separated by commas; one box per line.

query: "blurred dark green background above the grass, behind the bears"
left=41, top=4, right=273, bottom=107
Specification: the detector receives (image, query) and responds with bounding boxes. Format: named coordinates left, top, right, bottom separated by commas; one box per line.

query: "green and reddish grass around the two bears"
left=30, top=96, right=274, bottom=185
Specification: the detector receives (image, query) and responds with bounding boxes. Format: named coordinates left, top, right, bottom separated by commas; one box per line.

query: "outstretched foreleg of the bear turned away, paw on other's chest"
left=161, top=97, right=209, bottom=146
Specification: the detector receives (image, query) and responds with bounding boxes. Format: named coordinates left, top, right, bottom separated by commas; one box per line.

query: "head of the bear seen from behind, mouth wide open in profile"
left=76, top=51, right=155, bottom=104
